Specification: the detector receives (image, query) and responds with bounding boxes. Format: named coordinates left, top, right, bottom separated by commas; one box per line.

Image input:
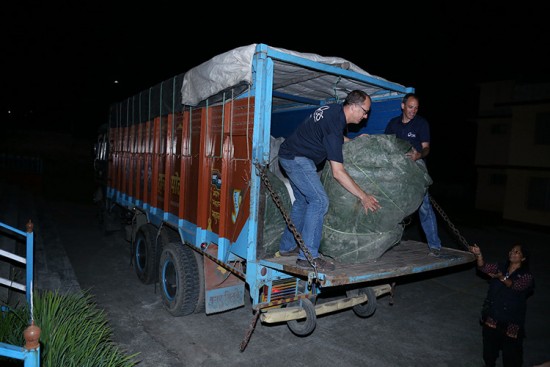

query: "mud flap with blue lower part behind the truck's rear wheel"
left=203, top=245, right=245, bottom=315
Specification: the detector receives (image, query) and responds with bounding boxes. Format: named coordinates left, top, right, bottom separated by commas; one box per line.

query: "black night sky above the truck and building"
left=0, top=1, right=549, bottom=187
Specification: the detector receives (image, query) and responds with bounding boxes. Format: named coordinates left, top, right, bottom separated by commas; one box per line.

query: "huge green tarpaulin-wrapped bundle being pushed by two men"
left=263, top=135, right=432, bottom=263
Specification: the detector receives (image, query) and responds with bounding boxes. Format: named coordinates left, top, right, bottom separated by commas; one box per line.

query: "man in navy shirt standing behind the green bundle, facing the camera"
left=384, top=93, right=441, bottom=256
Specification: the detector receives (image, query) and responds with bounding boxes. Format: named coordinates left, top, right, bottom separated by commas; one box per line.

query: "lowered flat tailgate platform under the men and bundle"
left=260, top=240, right=475, bottom=287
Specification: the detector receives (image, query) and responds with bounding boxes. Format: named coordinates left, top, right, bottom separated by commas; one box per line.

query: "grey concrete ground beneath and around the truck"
left=0, top=181, right=550, bottom=367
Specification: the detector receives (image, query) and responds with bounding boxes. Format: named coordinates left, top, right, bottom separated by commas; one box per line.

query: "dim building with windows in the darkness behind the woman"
left=475, top=81, right=550, bottom=226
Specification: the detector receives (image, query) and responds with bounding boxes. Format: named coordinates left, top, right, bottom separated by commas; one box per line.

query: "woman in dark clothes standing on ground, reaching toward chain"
left=469, top=244, right=534, bottom=367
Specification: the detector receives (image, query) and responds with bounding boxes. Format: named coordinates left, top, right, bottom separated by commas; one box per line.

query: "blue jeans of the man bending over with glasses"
left=279, top=157, right=329, bottom=260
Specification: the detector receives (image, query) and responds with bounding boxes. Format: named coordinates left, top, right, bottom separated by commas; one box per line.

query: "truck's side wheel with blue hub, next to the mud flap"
left=159, top=243, right=204, bottom=316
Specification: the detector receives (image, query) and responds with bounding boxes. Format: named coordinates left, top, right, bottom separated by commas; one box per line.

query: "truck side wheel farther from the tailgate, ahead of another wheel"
left=132, top=224, right=159, bottom=284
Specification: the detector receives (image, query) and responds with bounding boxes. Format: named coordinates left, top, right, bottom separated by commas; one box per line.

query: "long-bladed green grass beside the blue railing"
left=0, top=291, right=138, bottom=367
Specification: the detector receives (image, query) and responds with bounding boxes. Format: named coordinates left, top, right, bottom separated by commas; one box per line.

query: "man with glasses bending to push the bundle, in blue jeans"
left=279, top=90, right=380, bottom=271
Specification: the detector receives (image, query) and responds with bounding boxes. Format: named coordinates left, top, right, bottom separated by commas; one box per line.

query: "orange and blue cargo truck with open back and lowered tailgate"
left=95, top=44, right=474, bottom=350
